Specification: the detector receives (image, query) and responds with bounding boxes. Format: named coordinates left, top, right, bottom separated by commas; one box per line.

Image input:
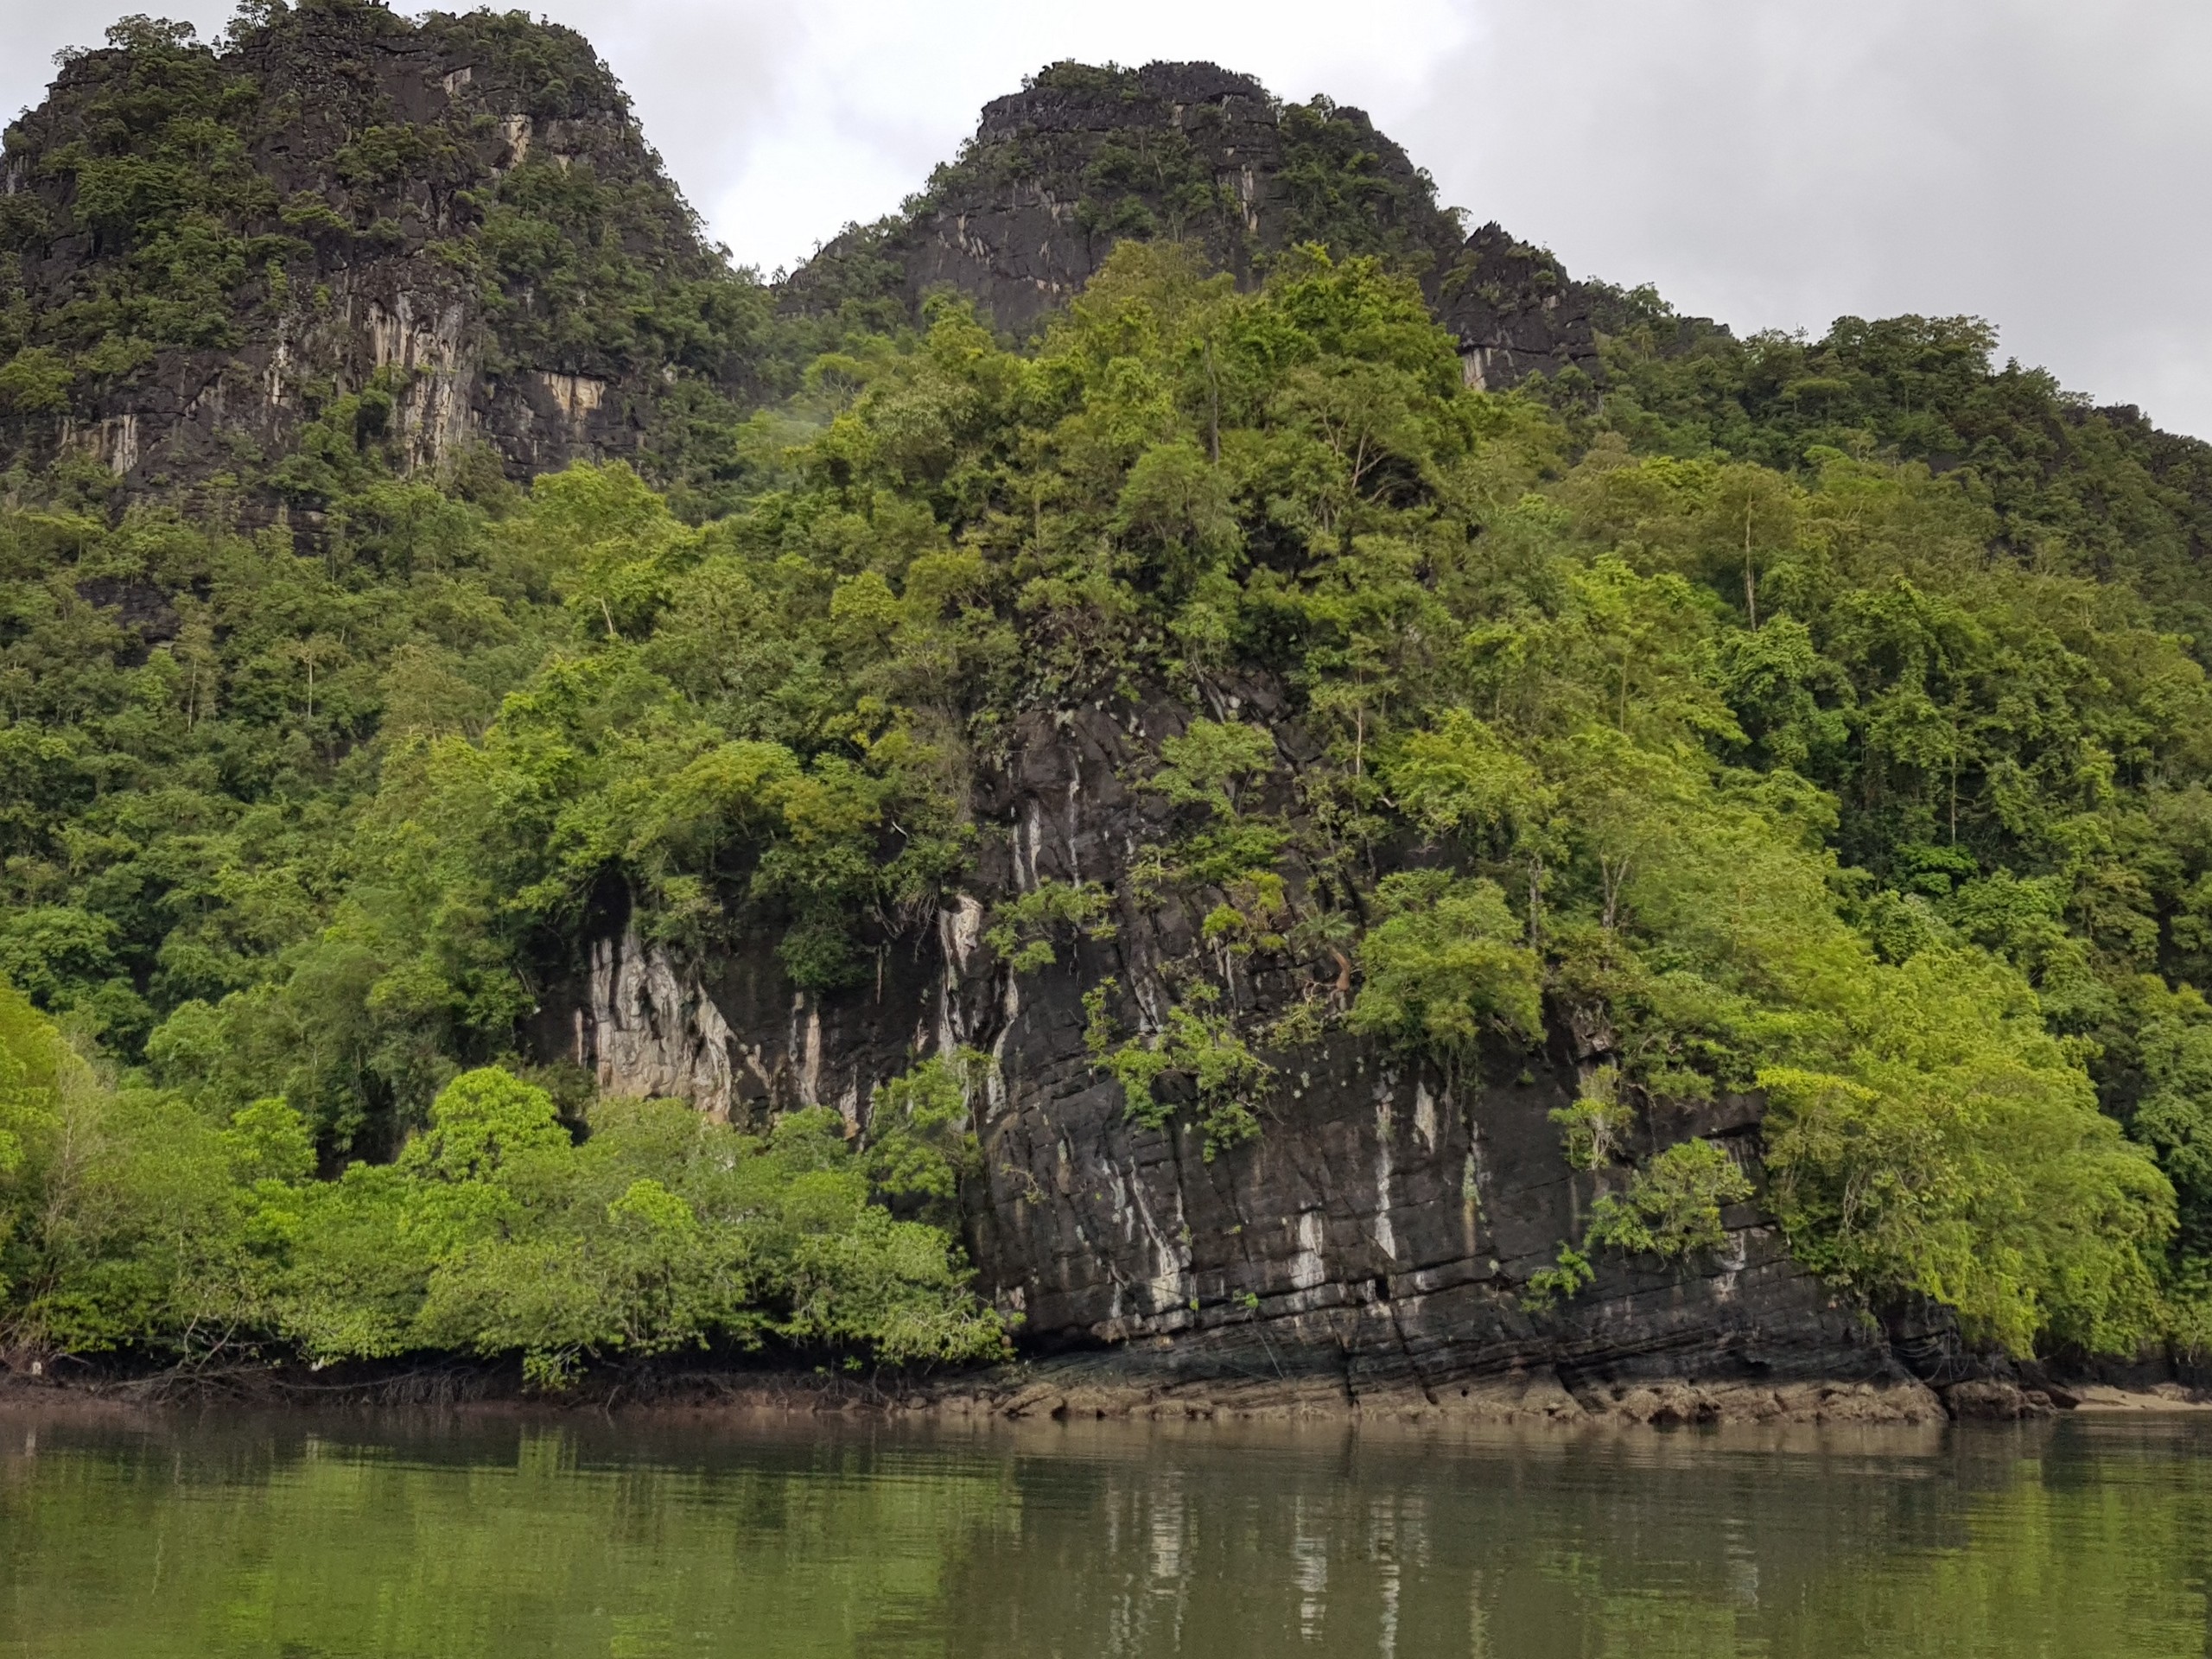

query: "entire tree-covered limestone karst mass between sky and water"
left=0, top=0, right=2212, bottom=1411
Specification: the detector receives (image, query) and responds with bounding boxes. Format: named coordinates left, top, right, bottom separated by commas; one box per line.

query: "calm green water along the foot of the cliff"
left=0, top=1414, right=2212, bottom=1659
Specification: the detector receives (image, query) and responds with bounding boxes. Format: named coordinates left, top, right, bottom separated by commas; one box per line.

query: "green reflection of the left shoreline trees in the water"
left=0, top=1421, right=1020, bottom=1659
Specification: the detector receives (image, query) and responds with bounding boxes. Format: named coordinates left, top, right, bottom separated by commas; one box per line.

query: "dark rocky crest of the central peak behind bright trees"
left=785, top=64, right=1645, bottom=400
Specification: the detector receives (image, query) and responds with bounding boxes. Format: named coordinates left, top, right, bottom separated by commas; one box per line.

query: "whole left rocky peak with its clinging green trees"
left=0, top=3, right=805, bottom=518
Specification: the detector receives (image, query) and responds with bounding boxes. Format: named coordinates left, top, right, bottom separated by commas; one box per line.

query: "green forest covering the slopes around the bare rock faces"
left=0, top=4, right=2212, bottom=1387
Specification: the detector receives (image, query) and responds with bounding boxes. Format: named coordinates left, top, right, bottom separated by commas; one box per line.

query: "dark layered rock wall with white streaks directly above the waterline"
left=978, top=1039, right=1891, bottom=1398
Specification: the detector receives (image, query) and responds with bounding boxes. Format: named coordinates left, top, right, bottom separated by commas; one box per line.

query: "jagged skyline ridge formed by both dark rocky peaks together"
left=0, top=28, right=1617, bottom=524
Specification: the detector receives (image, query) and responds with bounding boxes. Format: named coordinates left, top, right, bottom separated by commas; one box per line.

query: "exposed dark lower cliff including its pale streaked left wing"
left=537, top=686, right=1933, bottom=1415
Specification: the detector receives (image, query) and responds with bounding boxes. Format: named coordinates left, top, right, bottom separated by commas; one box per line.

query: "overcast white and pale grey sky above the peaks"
left=13, top=0, right=2212, bottom=435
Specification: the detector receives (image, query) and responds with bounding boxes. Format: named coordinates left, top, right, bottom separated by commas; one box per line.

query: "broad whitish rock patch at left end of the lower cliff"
left=591, top=929, right=736, bottom=1123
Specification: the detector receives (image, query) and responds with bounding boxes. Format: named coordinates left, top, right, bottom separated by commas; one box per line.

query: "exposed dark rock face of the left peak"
left=0, top=4, right=743, bottom=502
